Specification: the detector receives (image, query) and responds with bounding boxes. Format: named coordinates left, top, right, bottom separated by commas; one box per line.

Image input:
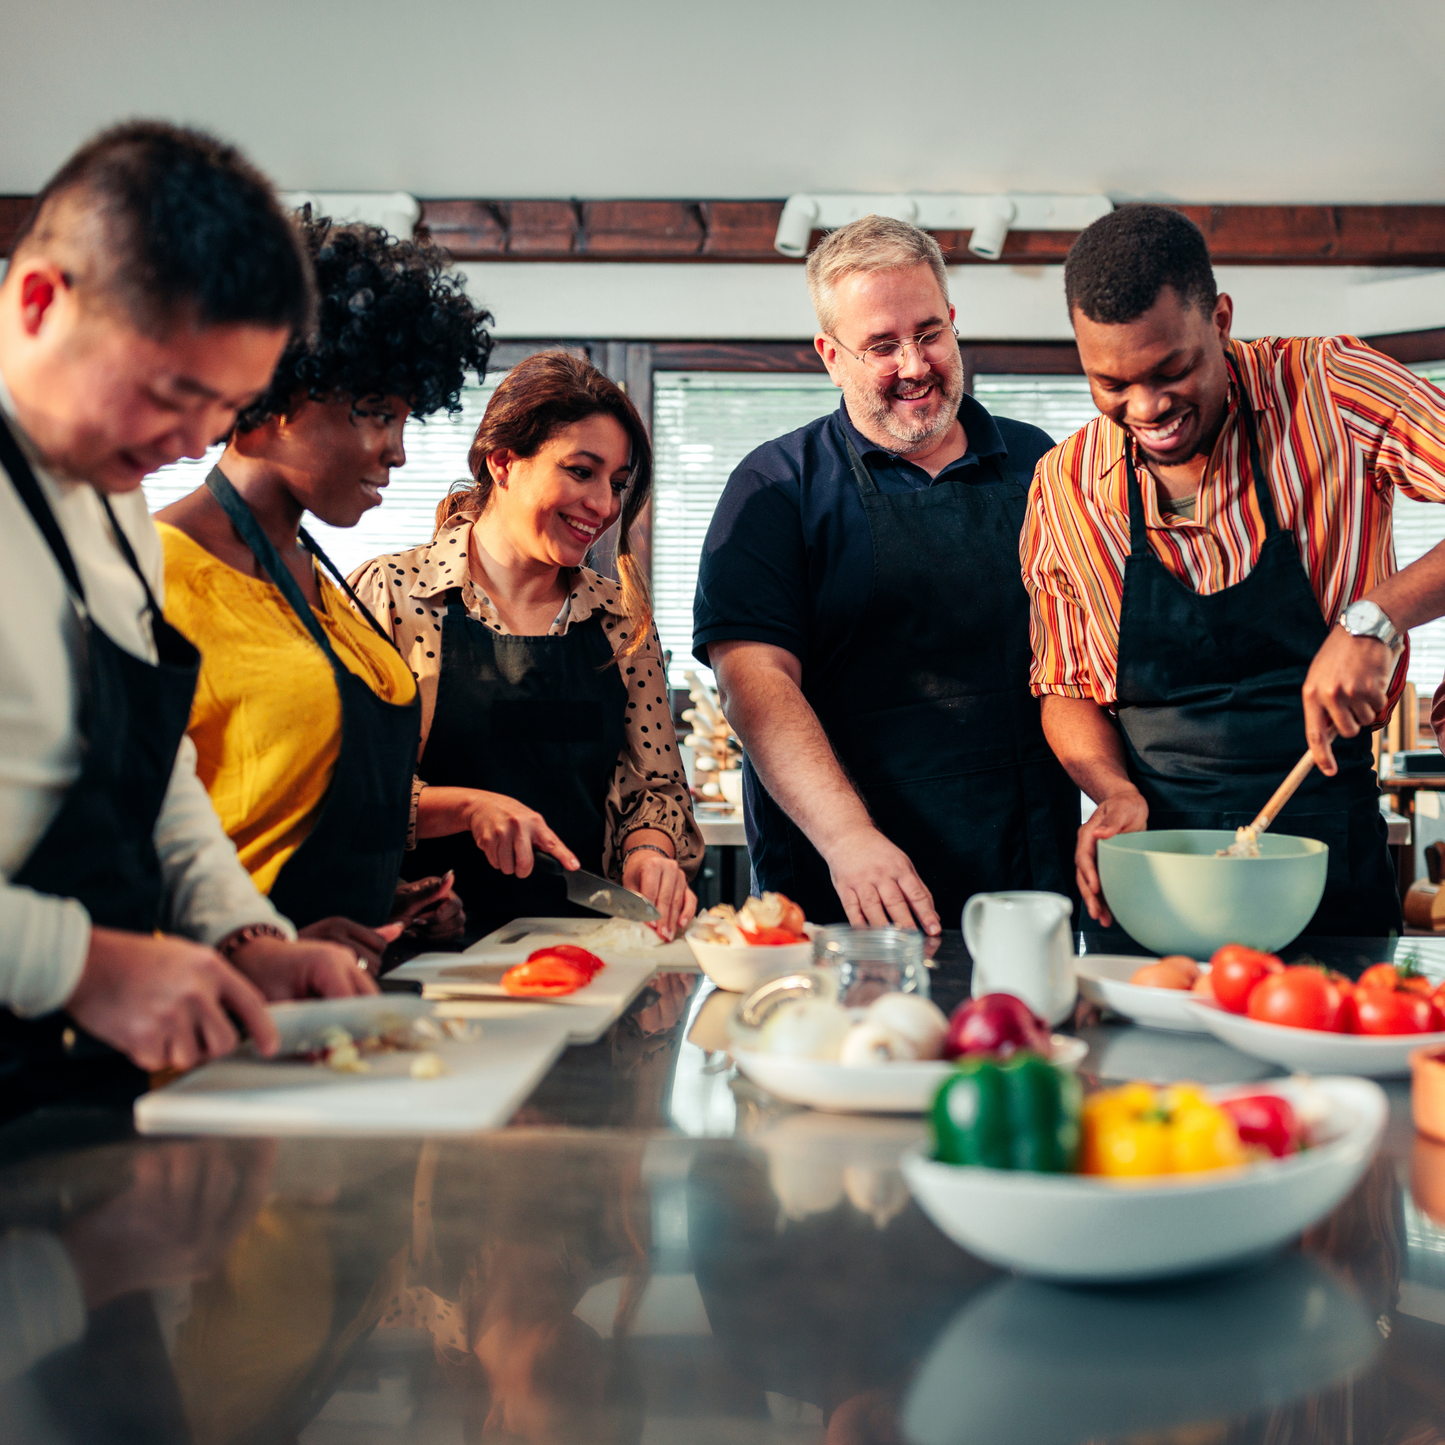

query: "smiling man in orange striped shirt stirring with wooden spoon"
left=1020, top=205, right=1445, bottom=936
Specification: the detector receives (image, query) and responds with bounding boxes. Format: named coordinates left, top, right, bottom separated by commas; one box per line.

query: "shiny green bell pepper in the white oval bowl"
left=931, top=1049, right=1084, bottom=1173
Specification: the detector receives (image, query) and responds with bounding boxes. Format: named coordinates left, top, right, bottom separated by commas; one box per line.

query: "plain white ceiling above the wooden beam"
left=8, top=0, right=1445, bottom=202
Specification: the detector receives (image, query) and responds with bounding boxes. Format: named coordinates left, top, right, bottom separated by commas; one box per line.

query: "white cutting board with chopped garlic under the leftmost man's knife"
left=136, top=994, right=568, bottom=1134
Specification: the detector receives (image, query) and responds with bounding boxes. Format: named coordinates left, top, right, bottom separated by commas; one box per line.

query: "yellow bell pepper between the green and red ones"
left=1082, top=1084, right=1248, bottom=1178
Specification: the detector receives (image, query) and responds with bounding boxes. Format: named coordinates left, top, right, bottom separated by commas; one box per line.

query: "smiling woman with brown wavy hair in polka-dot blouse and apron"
left=351, top=351, right=702, bottom=938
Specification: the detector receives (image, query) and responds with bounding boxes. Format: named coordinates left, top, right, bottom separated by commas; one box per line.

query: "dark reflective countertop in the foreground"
left=0, top=935, right=1445, bottom=1445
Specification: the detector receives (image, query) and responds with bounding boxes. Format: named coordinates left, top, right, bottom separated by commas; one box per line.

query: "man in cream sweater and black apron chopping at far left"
left=0, top=123, right=374, bottom=1118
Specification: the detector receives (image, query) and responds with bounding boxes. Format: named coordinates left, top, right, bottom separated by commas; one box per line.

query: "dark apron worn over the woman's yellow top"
left=205, top=467, right=422, bottom=928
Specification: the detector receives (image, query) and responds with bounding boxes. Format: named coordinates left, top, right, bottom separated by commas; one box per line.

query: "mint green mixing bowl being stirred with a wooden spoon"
left=1098, top=828, right=1329, bottom=958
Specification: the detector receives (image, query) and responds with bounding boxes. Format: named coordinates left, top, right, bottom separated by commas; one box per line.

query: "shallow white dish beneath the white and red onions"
left=733, top=1033, right=1088, bottom=1114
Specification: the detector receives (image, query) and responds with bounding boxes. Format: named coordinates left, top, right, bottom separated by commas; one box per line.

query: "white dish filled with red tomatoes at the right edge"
left=1189, top=944, right=1445, bottom=1078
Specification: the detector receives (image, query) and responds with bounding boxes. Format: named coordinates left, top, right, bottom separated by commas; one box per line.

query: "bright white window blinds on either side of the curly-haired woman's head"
left=145, top=384, right=504, bottom=586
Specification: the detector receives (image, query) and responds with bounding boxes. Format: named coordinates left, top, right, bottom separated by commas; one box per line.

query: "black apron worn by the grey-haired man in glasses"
left=744, top=423, right=1079, bottom=928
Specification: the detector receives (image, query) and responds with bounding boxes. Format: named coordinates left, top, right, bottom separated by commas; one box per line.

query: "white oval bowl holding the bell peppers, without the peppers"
left=902, top=1078, right=1389, bottom=1283
